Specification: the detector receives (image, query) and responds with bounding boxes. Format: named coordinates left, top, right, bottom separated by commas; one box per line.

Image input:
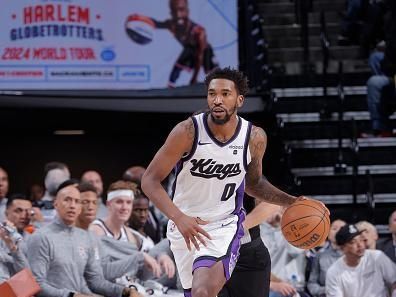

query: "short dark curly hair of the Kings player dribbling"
left=205, top=67, right=249, bottom=96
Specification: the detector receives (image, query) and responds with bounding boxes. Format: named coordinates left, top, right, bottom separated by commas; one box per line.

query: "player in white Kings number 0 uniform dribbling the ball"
left=142, top=68, right=328, bottom=297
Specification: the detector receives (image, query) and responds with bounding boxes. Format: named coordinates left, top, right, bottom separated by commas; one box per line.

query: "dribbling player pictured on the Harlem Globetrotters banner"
left=127, top=0, right=218, bottom=88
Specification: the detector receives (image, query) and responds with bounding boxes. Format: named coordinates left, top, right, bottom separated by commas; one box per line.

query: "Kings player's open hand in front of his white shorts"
left=175, top=215, right=212, bottom=251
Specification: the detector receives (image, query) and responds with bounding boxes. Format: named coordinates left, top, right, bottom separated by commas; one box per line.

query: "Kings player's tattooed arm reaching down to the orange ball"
left=245, top=126, right=297, bottom=206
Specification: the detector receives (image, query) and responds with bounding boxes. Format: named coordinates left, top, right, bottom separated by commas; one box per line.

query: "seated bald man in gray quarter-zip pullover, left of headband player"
left=28, top=180, right=136, bottom=297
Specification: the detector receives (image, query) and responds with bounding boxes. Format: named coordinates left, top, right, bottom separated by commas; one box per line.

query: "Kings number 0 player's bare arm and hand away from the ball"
left=142, top=118, right=210, bottom=249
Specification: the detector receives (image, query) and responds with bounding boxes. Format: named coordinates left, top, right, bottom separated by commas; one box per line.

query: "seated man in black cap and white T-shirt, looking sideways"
left=326, top=225, right=396, bottom=297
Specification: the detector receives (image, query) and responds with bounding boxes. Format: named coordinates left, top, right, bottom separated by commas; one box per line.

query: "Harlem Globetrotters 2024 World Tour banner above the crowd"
left=0, top=0, right=238, bottom=90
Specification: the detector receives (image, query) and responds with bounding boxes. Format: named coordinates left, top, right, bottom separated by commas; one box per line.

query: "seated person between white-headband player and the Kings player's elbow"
left=128, top=193, right=154, bottom=252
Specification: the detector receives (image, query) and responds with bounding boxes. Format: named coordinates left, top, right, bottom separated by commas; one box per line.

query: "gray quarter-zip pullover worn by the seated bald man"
left=27, top=217, right=123, bottom=297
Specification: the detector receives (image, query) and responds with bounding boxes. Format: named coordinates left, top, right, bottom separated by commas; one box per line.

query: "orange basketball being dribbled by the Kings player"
left=281, top=200, right=330, bottom=250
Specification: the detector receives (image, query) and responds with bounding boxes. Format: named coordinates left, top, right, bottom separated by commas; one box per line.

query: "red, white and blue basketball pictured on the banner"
left=125, top=14, right=155, bottom=45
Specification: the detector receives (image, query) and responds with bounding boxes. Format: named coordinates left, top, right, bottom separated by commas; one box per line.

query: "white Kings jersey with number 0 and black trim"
left=173, top=113, right=251, bottom=221
